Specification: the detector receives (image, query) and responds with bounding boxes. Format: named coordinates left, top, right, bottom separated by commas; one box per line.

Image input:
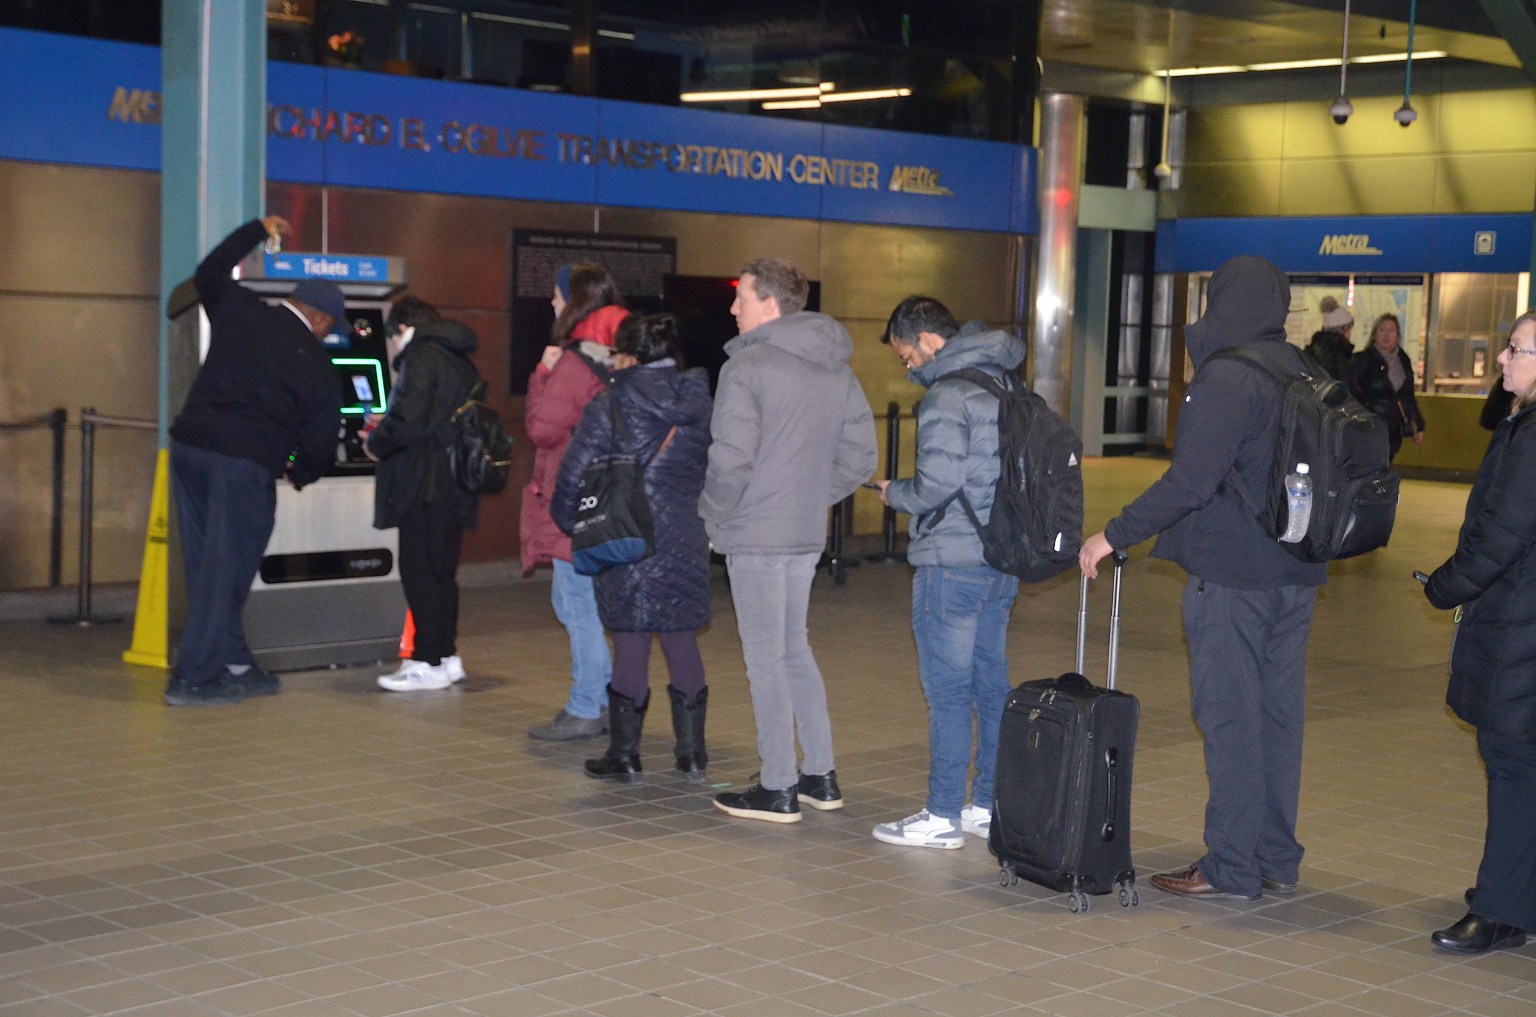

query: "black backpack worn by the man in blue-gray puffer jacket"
left=945, top=367, right=1083, bottom=582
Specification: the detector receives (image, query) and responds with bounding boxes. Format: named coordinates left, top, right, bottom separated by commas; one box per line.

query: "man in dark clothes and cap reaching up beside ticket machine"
left=164, top=215, right=347, bottom=707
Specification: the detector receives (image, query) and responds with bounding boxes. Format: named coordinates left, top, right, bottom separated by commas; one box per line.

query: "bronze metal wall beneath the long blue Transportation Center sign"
left=0, top=161, right=1028, bottom=588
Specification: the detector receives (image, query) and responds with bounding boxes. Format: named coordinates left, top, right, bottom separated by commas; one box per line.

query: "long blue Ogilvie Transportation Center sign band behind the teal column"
left=0, top=29, right=1038, bottom=234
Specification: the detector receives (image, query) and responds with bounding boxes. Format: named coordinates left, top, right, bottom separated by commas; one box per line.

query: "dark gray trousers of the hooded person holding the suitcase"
left=1184, top=576, right=1318, bottom=896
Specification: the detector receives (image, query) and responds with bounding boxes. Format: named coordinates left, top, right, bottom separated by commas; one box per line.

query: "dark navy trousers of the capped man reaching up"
left=170, top=441, right=278, bottom=685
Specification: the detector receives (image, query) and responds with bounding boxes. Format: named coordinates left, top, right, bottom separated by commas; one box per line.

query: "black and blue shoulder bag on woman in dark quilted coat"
left=571, top=392, right=677, bottom=576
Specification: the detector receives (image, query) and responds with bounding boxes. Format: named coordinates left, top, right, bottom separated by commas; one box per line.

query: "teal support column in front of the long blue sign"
left=160, top=0, right=267, bottom=449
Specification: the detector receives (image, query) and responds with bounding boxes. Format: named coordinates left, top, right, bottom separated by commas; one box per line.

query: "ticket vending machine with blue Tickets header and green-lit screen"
left=172, top=250, right=406, bottom=671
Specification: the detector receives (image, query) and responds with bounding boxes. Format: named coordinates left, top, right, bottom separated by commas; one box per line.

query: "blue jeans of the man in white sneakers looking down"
left=912, top=565, right=1018, bottom=822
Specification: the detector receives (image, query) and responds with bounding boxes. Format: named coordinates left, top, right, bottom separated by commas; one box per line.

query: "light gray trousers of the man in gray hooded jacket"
left=725, top=553, right=833, bottom=791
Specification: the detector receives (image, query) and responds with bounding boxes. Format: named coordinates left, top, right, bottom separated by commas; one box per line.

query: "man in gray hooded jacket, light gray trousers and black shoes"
left=699, top=258, right=877, bottom=823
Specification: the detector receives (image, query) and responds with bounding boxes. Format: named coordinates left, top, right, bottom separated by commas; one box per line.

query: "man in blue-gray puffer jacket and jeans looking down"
left=874, top=296, right=1025, bottom=848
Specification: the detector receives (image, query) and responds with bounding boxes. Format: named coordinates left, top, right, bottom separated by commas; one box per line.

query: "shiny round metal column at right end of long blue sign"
left=1029, top=92, right=1087, bottom=416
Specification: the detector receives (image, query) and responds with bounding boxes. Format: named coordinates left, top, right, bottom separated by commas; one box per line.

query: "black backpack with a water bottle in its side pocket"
left=1212, top=343, right=1401, bottom=562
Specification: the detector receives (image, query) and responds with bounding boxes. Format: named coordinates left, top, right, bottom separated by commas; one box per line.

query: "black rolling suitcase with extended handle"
left=988, top=555, right=1141, bottom=913
